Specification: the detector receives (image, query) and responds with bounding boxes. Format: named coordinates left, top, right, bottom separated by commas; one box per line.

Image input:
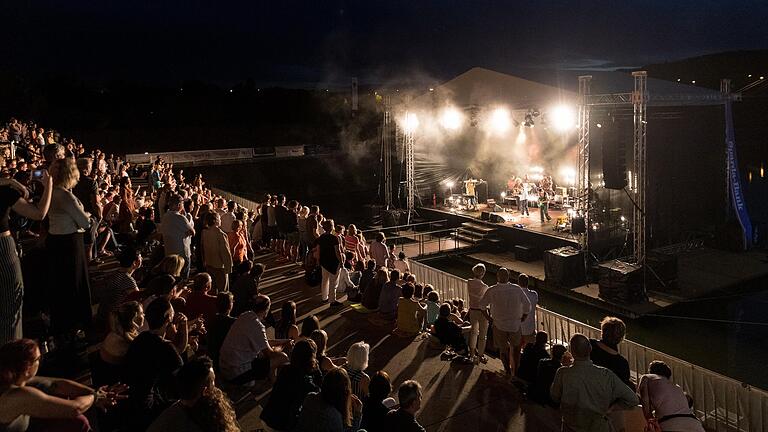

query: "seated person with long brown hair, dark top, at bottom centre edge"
left=294, top=368, right=364, bottom=432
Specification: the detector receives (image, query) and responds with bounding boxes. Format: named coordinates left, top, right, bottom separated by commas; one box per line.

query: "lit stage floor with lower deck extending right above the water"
left=418, top=204, right=768, bottom=318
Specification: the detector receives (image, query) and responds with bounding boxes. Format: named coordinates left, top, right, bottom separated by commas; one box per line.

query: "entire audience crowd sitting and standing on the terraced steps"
left=0, top=119, right=703, bottom=432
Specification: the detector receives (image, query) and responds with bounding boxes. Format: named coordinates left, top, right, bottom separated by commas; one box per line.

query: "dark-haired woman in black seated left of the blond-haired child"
left=261, top=339, right=323, bottom=431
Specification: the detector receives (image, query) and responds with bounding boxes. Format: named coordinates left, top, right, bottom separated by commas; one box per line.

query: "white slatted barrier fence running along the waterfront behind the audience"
left=409, top=261, right=768, bottom=432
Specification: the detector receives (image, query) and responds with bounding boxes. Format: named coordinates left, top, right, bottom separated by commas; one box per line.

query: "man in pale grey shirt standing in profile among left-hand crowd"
left=159, top=194, right=195, bottom=279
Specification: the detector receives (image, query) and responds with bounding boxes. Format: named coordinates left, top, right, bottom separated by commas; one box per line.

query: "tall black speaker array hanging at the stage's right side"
left=597, top=114, right=629, bottom=190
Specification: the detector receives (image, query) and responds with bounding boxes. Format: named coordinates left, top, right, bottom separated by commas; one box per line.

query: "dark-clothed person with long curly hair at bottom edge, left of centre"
left=147, top=357, right=240, bottom=432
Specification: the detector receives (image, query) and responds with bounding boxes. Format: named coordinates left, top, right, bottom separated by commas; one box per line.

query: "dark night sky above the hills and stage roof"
left=0, top=0, right=768, bottom=85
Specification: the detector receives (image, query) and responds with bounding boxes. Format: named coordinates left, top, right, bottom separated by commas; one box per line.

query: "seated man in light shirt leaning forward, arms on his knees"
left=219, top=294, right=293, bottom=384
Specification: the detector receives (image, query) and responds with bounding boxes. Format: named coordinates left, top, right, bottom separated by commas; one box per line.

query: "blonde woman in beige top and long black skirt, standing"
left=45, top=158, right=91, bottom=341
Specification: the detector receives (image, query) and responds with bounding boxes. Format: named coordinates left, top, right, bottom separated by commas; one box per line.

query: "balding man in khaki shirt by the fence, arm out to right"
left=550, top=333, right=640, bottom=432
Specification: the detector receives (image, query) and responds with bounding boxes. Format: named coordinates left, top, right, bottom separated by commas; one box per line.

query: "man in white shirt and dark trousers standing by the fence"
left=479, top=267, right=531, bottom=376
